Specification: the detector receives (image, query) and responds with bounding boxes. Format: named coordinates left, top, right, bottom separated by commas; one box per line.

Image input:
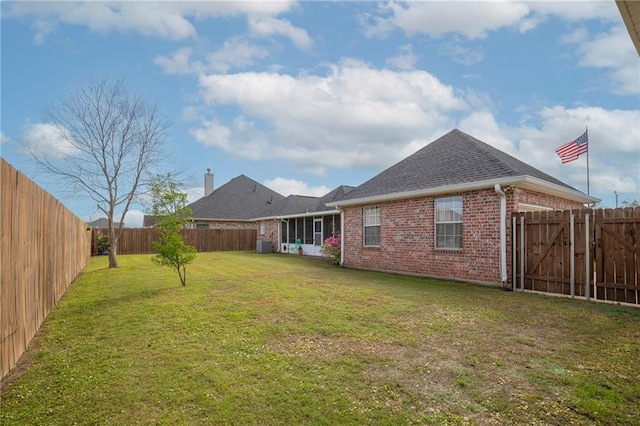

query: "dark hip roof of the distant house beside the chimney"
left=187, top=175, right=284, bottom=220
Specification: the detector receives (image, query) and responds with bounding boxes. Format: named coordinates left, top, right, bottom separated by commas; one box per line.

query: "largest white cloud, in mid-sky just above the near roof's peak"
left=192, top=60, right=467, bottom=175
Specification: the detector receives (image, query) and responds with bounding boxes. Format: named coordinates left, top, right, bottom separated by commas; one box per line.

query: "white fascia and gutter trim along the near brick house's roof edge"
left=327, top=176, right=600, bottom=208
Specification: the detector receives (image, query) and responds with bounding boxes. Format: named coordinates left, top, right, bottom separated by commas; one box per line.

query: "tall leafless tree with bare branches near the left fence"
left=26, top=77, right=167, bottom=268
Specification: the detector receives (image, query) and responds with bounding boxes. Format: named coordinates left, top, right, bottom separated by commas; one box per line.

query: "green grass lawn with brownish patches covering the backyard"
left=0, top=253, right=640, bottom=425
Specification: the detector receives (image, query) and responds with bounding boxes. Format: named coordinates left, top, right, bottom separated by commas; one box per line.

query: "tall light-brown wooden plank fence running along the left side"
left=0, top=158, right=91, bottom=377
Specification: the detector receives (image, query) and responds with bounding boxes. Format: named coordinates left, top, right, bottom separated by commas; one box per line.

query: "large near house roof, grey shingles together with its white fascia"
left=329, top=129, right=598, bottom=207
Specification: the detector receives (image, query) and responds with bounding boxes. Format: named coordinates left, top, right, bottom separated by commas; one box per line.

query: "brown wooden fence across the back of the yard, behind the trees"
left=91, top=228, right=257, bottom=254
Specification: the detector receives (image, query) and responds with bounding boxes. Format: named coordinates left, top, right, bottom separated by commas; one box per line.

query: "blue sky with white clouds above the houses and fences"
left=0, top=0, right=640, bottom=226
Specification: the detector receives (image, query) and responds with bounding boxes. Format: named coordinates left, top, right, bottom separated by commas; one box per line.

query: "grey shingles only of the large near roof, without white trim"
left=343, top=129, right=575, bottom=200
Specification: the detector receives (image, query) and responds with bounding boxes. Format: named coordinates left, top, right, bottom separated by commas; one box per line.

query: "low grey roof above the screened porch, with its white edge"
left=258, top=185, right=354, bottom=219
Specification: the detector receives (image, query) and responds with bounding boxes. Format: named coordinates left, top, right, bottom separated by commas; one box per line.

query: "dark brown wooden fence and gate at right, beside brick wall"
left=511, top=208, right=640, bottom=305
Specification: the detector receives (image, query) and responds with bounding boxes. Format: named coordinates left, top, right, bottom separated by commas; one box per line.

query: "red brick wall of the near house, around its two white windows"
left=344, top=188, right=581, bottom=284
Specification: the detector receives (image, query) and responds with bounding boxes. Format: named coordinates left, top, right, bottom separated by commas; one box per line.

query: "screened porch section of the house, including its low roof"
left=255, top=185, right=353, bottom=256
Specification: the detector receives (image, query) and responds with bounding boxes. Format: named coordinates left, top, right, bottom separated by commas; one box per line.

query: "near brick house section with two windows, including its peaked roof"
left=328, top=129, right=599, bottom=285
